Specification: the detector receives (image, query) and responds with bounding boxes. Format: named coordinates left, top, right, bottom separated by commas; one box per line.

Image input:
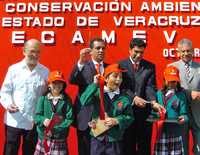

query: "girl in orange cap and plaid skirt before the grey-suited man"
left=154, top=66, right=188, bottom=155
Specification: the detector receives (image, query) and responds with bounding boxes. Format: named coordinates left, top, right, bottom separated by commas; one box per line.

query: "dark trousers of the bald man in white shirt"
left=4, top=125, right=37, bottom=155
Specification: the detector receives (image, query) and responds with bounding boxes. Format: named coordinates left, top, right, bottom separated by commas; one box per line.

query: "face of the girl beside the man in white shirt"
left=50, top=81, right=64, bottom=95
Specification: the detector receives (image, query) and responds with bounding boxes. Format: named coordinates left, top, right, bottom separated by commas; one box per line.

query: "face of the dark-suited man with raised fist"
left=91, top=41, right=106, bottom=62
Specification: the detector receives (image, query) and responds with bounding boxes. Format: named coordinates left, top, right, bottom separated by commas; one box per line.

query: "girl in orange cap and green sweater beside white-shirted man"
left=34, top=71, right=73, bottom=155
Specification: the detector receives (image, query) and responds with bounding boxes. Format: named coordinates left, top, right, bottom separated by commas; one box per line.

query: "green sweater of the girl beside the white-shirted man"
left=34, top=96, right=73, bottom=140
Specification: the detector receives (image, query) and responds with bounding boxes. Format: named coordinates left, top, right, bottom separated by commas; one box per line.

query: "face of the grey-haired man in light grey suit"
left=178, top=44, right=193, bottom=62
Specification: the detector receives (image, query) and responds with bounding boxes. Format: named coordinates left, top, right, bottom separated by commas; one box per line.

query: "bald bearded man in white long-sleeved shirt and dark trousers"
left=0, top=39, right=49, bottom=155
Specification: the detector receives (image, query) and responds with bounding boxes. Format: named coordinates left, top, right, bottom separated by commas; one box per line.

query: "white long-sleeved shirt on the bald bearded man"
left=0, top=60, right=49, bottom=130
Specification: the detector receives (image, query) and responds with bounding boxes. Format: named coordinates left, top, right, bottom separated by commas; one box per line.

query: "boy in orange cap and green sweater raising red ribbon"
left=80, top=64, right=134, bottom=155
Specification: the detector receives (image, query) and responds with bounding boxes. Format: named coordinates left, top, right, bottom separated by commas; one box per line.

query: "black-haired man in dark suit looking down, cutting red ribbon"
left=120, top=39, right=162, bottom=155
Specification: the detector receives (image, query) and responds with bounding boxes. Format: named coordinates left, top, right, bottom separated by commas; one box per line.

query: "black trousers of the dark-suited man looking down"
left=123, top=121, right=152, bottom=155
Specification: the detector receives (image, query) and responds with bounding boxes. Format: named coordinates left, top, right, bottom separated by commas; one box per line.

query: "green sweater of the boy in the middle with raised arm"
left=80, top=84, right=134, bottom=142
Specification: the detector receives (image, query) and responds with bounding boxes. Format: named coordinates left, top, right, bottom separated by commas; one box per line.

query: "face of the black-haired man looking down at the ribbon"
left=129, top=46, right=144, bottom=62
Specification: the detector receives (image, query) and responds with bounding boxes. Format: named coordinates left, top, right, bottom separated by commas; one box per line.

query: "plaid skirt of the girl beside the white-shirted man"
left=34, top=139, right=68, bottom=155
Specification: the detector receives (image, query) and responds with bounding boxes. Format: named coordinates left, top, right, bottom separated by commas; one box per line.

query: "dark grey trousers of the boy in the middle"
left=91, top=137, right=123, bottom=155
